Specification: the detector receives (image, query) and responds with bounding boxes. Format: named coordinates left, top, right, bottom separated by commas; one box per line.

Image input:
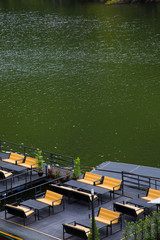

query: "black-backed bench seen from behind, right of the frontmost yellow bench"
left=113, top=202, right=144, bottom=220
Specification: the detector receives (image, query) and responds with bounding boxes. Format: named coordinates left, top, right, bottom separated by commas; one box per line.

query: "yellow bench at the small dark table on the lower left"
left=36, top=190, right=64, bottom=213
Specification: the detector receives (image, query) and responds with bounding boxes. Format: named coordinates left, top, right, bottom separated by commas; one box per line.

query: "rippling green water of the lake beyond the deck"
left=0, top=0, right=160, bottom=167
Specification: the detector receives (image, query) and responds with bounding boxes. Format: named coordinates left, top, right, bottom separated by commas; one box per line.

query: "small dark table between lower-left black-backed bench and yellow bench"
left=21, top=199, right=50, bottom=220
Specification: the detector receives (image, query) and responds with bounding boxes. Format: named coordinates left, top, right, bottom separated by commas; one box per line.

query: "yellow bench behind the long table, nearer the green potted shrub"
left=77, top=172, right=102, bottom=185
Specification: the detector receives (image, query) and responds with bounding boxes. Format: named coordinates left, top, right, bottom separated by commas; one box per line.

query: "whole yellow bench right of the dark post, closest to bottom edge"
left=95, top=208, right=122, bottom=235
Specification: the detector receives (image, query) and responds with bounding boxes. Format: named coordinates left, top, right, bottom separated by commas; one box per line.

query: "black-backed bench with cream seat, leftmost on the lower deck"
left=5, top=204, right=36, bottom=225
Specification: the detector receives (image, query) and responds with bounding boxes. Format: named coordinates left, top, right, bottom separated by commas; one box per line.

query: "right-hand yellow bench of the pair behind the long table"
left=95, top=176, right=122, bottom=197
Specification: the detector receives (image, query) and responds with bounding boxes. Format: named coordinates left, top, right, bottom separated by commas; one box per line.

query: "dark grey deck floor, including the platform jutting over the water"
left=0, top=157, right=160, bottom=240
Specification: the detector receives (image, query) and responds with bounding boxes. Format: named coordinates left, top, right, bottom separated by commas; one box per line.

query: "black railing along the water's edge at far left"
left=0, top=140, right=74, bottom=169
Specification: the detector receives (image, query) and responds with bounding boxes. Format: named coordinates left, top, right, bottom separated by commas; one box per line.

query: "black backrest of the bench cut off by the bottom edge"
left=63, top=224, right=88, bottom=239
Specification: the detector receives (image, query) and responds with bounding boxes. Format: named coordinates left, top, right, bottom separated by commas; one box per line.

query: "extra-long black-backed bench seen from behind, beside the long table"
left=50, top=184, right=99, bottom=209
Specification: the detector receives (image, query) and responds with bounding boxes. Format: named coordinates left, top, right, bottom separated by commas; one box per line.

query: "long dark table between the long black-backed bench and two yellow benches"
left=64, top=180, right=110, bottom=202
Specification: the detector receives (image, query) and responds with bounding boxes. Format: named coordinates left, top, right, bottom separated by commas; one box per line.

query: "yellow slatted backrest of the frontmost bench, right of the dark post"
left=98, top=208, right=120, bottom=223
